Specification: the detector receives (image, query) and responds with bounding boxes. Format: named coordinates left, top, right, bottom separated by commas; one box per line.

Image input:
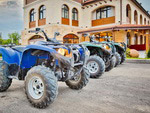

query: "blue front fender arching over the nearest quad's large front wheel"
left=20, top=45, right=70, bottom=69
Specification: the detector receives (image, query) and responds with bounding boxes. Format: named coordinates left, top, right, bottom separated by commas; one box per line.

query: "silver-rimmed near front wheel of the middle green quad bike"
left=87, top=55, right=105, bottom=78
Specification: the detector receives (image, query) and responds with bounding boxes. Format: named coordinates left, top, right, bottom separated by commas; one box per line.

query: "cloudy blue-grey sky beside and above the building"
left=0, top=0, right=150, bottom=39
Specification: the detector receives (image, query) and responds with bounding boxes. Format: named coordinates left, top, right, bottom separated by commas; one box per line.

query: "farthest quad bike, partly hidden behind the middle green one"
left=102, top=37, right=127, bottom=67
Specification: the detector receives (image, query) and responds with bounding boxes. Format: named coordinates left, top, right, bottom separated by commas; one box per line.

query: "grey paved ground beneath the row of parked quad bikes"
left=0, top=63, right=150, bottom=113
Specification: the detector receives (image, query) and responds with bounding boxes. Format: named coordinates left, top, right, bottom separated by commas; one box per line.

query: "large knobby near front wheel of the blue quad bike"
left=25, top=66, right=58, bottom=108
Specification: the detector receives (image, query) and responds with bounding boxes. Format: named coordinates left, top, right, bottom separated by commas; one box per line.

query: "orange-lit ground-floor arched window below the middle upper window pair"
left=63, top=34, right=79, bottom=44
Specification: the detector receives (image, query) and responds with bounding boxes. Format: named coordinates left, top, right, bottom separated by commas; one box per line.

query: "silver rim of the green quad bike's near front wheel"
left=87, top=61, right=99, bottom=74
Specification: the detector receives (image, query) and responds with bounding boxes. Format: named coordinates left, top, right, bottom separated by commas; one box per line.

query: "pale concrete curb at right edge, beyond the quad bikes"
left=126, top=59, right=150, bottom=64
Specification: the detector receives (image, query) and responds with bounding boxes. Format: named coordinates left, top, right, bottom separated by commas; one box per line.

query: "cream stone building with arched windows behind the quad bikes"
left=22, top=0, right=150, bottom=51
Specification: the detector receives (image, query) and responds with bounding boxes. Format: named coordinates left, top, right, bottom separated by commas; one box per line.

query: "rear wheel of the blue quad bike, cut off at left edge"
left=0, top=61, right=12, bottom=92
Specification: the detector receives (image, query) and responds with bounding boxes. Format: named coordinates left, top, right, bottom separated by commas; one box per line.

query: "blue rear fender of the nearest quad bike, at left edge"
left=0, top=47, right=20, bottom=65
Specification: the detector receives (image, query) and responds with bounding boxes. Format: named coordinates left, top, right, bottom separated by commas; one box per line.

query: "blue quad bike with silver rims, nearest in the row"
left=0, top=28, right=90, bottom=108
